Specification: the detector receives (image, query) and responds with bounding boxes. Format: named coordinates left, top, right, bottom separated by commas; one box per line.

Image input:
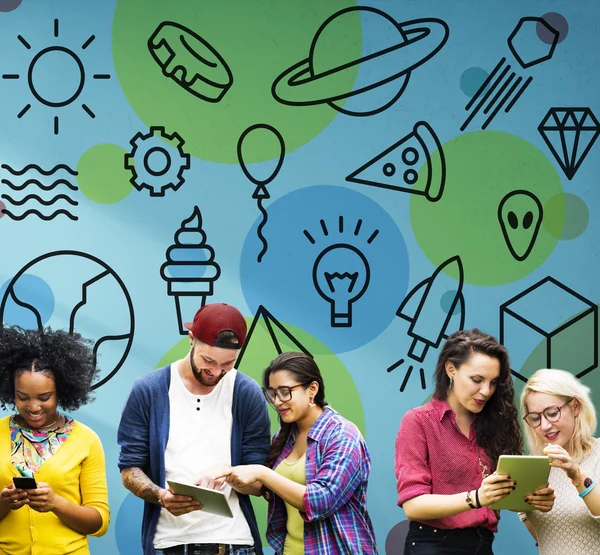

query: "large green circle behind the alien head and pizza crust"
left=410, top=131, right=563, bottom=285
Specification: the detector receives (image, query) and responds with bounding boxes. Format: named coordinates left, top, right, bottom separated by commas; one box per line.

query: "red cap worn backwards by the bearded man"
left=184, top=303, right=248, bottom=349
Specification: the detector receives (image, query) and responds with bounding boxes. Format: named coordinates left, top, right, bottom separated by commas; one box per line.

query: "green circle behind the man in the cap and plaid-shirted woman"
left=155, top=318, right=365, bottom=543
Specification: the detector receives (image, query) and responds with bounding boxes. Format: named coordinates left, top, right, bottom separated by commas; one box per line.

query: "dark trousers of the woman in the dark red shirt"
left=404, top=522, right=494, bottom=555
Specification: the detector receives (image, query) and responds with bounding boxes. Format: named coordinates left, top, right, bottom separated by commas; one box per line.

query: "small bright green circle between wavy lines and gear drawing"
left=77, top=144, right=133, bottom=204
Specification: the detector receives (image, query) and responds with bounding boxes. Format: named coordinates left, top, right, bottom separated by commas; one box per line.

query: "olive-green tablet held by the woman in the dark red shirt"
left=490, top=455, right=550, bottom=512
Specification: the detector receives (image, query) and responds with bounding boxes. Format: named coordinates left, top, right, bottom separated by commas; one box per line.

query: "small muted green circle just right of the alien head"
left=544, top=193, right=590, bottom=241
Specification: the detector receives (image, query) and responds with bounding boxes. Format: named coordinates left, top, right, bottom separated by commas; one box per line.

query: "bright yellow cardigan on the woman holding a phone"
left=0, top=416, right=110, bottom=555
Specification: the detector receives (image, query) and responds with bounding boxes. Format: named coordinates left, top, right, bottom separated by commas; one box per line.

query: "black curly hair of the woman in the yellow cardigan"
left=0, top=326, right=98, bottom=410
